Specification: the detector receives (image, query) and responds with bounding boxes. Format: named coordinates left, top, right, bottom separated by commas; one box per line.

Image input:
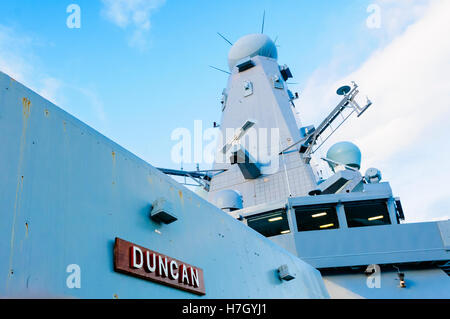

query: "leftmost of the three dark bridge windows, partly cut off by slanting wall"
left=247, top=209, right=291, bottom=237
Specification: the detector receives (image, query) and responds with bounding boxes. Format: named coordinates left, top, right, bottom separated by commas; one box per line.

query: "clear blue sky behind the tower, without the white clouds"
left=0, top=0, right=380, bottom=166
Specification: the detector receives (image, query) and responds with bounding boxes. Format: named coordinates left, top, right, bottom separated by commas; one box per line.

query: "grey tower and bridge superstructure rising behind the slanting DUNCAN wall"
left=197, top=34, right=450, bottom=298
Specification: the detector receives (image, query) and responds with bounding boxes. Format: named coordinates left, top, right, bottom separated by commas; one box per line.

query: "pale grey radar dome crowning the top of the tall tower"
left=228, top=34, right=278, bottom=70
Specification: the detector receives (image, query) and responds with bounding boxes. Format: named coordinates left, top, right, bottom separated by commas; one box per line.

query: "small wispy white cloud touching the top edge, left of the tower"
left=102, top=0, right=165, bottom=49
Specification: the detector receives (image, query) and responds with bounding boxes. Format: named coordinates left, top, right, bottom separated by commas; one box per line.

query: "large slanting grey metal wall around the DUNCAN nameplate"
left=0, top=73, right=328, bottom=298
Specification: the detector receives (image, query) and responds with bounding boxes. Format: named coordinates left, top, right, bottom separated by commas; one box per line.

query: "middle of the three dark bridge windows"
left=295, top=205, right=339, bottom=231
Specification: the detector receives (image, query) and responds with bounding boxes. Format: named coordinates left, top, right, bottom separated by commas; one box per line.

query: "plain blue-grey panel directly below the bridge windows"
left=294, top=222, right=450, bottom=268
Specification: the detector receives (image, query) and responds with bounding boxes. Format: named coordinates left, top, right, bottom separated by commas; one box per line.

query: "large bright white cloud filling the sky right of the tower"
left=301, top=0, right=450, bottom=221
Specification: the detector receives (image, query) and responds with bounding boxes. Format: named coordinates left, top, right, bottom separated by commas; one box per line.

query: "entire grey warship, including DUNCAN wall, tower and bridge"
left=0, top=29, right=450, bottom=299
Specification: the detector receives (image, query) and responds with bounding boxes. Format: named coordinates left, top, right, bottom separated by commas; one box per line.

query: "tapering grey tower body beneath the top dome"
left=209, top=56, right=316, bottom=207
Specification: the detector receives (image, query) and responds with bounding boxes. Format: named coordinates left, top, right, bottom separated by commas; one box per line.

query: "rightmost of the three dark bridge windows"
left=344, top=200, right=391, bottom=228
